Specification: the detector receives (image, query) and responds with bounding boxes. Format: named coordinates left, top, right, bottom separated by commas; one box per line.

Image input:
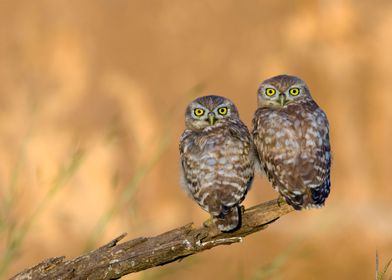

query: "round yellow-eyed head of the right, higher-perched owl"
left=257, top=75, right=310, bottom=108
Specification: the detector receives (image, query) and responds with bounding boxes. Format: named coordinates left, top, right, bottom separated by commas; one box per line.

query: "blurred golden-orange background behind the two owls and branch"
left=0, top=0, right=392, bottom=279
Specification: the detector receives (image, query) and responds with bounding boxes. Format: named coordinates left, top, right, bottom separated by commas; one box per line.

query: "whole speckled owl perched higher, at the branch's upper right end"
left=252, top=75, right=331, bottom=210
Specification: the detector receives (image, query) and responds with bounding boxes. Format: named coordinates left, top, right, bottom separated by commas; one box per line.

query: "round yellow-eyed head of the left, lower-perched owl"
left=185, top=95, right=239, bottom=131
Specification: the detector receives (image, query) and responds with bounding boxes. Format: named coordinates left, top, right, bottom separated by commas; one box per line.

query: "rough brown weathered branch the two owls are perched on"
left=11, top=200, right=293, bottom=280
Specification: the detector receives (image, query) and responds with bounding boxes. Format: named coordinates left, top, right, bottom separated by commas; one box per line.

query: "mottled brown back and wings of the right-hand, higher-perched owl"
left=253, top=100, right=330, bottom=208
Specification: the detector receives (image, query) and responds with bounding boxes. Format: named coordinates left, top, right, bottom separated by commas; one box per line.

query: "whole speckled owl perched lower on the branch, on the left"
left=180, top=95, right=257, bottom=232
